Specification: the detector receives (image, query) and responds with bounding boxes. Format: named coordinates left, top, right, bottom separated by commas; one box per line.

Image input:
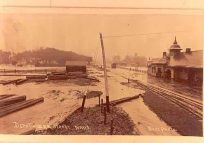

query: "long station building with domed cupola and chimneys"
left=147, top=38, right=203, bottom=85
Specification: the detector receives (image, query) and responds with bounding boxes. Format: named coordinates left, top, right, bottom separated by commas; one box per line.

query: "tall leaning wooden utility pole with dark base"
left=100, top=33, right=110, bottom=112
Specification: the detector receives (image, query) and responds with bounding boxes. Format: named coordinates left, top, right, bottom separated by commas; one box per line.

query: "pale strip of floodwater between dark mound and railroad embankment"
left=120, top=97, right=179, bottom=136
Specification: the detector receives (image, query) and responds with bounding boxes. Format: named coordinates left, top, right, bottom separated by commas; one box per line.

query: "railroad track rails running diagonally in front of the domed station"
left=129, top=80, right=203, bottom=120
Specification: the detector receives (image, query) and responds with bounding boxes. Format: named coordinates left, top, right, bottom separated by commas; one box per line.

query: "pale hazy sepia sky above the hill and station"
left=0, top=0, right=204, bottom=62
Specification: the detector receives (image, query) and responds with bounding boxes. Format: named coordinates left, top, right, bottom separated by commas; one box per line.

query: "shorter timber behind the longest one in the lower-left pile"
left=0, top=96, right=26, bottom=107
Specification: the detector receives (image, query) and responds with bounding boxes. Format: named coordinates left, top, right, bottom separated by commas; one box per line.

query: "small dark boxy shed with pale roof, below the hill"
left=66, top=61, right=88, bottom=73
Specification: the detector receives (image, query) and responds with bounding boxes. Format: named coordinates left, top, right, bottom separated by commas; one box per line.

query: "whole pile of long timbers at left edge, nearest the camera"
left=0, top=94, right=44, bottom=117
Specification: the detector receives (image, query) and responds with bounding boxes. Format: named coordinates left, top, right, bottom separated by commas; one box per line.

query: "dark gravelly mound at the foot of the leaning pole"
left=34, top=106, right=137, bottom=135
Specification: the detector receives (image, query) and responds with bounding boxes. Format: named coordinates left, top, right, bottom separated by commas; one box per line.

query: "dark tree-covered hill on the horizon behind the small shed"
left=0, top=48, right=92, bottom=66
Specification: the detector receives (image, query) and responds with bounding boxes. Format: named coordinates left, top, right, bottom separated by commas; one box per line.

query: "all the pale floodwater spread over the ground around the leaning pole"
left=0, top=67, right=201, bottom=135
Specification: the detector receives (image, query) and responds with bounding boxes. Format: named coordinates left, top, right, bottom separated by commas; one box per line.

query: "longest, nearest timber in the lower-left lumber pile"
left=0, top=97, right=44, bottom=117
